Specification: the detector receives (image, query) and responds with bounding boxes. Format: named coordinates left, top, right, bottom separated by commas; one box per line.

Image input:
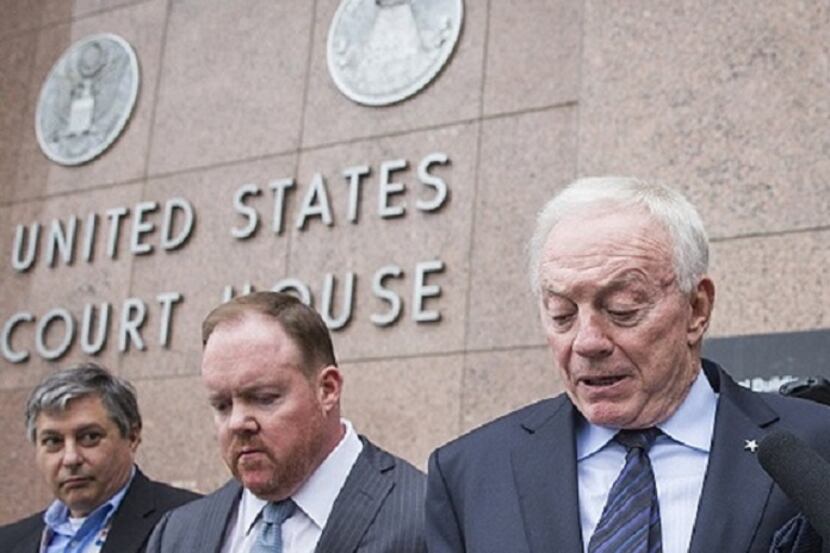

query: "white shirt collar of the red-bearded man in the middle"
left=241, top=419, right=363, bottom=534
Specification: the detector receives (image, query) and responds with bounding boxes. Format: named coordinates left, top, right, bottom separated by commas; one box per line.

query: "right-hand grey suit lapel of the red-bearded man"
left=315, top=440, right=395, bottom=553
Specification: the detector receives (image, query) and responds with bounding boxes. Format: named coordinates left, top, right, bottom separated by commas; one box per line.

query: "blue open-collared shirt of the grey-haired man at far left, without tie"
left=41, top=467, right=135, bottom=553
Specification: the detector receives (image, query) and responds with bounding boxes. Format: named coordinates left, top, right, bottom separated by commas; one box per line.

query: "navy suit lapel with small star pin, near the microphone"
left=689, top=361, right=778, bottom=553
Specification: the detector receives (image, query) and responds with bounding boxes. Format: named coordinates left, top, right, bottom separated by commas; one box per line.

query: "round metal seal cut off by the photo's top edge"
left=327, top=0, right=464, bottom=106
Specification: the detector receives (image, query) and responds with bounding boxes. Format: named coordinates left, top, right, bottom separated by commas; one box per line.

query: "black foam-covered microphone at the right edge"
left=758, top=430, right=830, bottom=543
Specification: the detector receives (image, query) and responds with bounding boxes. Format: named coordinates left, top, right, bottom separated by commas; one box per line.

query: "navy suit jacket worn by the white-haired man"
left=426, top=360, right=830, bottom=553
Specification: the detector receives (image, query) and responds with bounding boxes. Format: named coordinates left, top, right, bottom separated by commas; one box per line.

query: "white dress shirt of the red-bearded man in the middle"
left=222, top=419, right=363, bottom=553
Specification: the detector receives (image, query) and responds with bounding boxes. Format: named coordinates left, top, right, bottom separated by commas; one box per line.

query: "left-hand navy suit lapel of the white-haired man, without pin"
left=511, top=397, right=582, bottom=553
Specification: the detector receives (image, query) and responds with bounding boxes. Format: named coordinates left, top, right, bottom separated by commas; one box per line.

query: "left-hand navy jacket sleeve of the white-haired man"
left=426, top=449, right=466, bottom=553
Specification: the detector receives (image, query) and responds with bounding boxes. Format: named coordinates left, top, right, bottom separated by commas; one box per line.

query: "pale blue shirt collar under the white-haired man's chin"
left=576, top=370, right=718, bottom=461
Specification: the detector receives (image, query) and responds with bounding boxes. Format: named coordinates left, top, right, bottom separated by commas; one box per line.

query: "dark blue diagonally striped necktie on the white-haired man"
left=588, top=428, right=663, bottom=553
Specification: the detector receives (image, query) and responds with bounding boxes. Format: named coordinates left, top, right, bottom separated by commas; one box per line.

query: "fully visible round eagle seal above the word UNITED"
left=35, top=33, right=139, bottom=165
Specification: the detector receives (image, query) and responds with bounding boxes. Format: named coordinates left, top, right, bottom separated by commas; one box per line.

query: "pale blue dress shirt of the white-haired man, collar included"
left=576, top=370, right=718, bottom=553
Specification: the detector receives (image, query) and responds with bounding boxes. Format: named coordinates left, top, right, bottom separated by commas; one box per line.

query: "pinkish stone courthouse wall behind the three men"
left=0, top=0, right=830, bottom=523
